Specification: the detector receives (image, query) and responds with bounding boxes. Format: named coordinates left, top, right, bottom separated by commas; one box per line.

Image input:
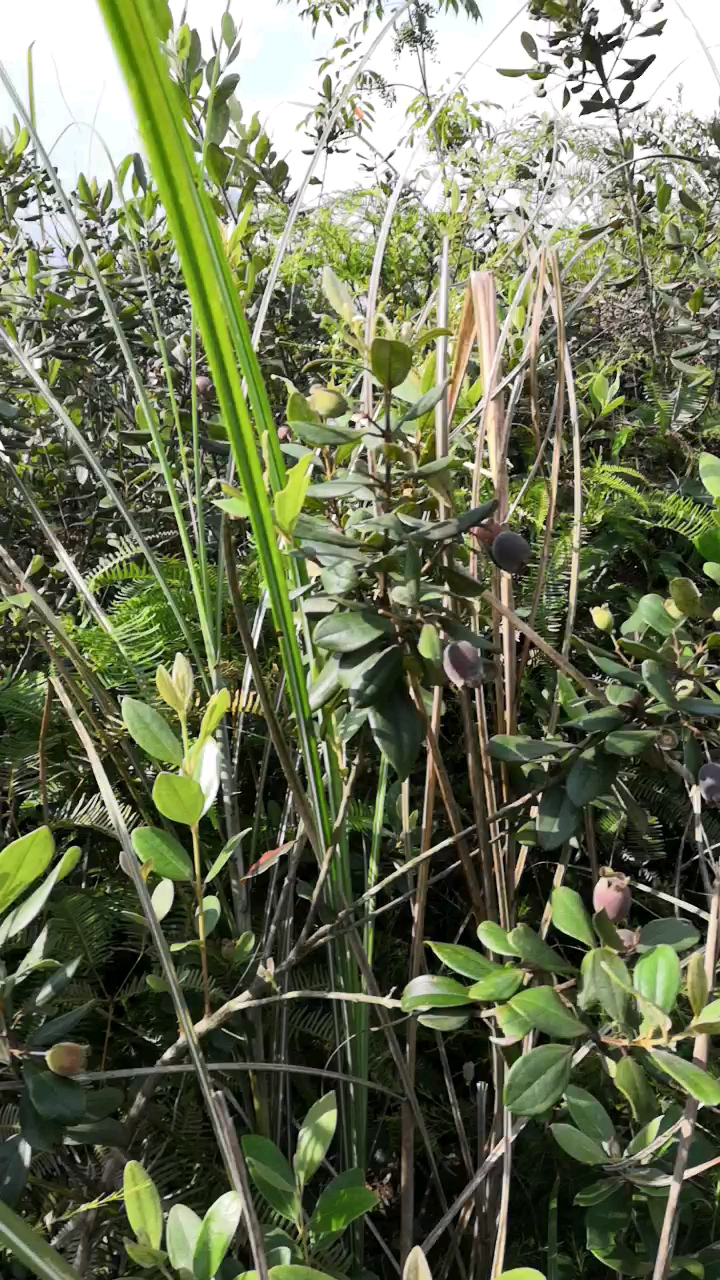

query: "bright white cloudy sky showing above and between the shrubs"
left=0, top=0, right=720, bottom=186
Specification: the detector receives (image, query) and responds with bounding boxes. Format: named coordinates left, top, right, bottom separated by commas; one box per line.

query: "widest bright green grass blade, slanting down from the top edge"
left=99, top=0, right=328, bottom=847
